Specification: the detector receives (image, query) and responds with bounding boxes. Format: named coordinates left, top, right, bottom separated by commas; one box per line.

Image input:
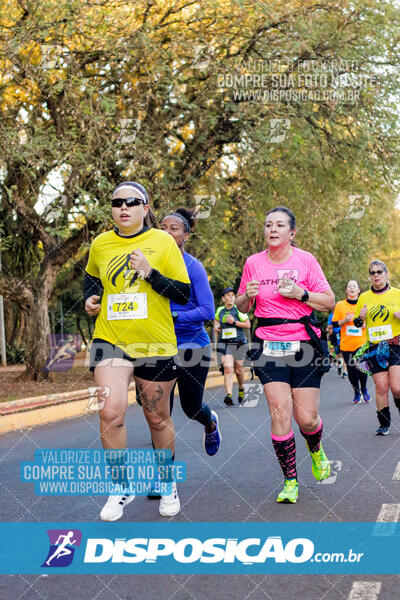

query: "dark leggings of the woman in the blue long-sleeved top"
left=136, top=346, right=212, bottom=426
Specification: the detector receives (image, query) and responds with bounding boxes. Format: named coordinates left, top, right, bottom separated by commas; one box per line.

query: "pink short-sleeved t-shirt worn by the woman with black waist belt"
left=238, top=247, right=331, bottom=341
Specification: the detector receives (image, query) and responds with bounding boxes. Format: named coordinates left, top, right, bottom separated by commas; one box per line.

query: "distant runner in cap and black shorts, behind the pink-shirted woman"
left=214, top=287, right=251, bottom=406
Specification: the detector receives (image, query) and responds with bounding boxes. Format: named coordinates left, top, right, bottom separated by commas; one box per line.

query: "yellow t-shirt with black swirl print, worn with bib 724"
left=86, top=229, right=190, bottom=358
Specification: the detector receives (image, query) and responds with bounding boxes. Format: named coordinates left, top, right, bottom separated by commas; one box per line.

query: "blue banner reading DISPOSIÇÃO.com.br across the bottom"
left=0, top=522, right=400, bottom=574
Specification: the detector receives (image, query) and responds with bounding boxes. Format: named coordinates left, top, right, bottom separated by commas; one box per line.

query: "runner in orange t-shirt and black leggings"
left=332, top=279, right=371, bottom=404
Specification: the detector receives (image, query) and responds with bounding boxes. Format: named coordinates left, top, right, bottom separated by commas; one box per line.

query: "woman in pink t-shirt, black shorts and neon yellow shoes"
left=236, top=206, right=335, bottom=503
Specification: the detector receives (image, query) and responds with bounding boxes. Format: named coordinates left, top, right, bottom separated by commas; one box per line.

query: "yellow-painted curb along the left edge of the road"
left=0, top=367, right=250, bottom=435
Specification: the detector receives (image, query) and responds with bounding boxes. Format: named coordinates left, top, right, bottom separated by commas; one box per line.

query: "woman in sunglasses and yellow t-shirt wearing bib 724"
left=84, top=182, right=190, bottom=521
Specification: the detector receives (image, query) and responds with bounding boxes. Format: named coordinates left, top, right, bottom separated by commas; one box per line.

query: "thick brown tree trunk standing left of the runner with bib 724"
left=20, top=264, right=56, bottom=381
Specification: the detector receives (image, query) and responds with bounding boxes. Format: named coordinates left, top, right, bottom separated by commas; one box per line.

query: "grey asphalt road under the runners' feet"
left=0, top=372, right=400, bottom=600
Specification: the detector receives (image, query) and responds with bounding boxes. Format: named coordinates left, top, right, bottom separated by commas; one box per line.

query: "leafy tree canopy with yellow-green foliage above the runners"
left=0, top=0, right=400, bottom=377
